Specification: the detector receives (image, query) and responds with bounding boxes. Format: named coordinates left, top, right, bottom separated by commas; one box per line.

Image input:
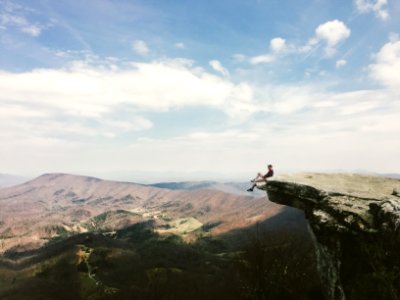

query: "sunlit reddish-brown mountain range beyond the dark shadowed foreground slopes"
left=0, top=174, right=302, bottom=253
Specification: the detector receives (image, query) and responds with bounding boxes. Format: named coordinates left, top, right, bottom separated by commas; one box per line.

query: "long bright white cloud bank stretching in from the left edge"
left=0, top=59, right=254, bottom=118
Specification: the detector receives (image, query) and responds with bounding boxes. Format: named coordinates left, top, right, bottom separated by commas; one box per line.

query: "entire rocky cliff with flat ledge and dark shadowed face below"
left=259, top=173, right=400, bottom=300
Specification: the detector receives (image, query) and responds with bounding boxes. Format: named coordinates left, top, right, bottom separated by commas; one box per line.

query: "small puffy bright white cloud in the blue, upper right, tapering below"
left=315, top=20, right=351, bottom=56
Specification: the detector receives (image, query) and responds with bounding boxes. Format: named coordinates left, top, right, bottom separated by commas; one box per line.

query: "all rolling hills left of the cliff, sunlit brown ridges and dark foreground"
left=0, top=174, right=318, bottom=300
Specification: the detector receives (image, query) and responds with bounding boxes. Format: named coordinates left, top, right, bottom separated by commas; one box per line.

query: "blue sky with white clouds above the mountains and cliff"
left=0, top=0, right=400, bottom=181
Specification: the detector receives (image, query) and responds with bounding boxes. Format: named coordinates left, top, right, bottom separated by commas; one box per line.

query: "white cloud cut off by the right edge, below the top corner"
left=369, top=40, right=400, bottom=90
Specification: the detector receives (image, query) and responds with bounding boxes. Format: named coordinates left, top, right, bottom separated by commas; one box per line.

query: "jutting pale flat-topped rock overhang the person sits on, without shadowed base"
left=258, top=173, right=400, bottom=233
